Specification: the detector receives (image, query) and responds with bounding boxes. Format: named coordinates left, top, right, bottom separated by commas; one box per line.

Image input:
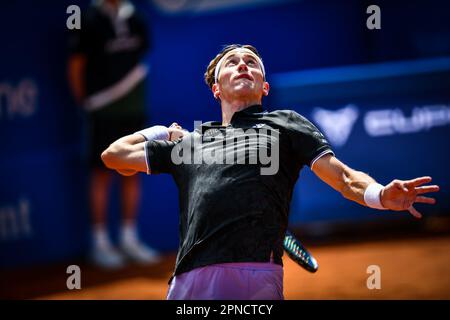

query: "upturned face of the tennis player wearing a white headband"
left=217, top=50, right=268, bottom=101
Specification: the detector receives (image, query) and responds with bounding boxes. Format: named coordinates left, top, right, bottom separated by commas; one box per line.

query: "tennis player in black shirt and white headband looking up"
left=102, top=45, right=439, bottom=300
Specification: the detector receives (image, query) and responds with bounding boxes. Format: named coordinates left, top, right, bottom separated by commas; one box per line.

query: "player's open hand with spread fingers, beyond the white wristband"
left=380, top=177, right=439, bottom=218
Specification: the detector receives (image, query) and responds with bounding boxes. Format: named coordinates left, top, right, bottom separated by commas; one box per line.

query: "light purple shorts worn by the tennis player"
left=167, top=262, right=284, bottom=300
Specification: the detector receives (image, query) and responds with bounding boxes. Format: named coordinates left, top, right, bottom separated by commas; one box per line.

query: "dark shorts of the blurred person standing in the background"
left=87, top=83, right=147, bottom=168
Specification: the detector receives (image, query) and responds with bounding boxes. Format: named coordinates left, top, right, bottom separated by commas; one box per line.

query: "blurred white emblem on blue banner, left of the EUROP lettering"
left=312, top=104, right=359, bottom=147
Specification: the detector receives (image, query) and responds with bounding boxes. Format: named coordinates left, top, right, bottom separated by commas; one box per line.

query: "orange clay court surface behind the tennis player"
left=0, top=235, right=450, bottom=300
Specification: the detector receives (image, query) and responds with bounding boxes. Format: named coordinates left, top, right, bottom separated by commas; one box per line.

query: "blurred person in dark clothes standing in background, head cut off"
left=68, top=0, right=158, bottom=268
